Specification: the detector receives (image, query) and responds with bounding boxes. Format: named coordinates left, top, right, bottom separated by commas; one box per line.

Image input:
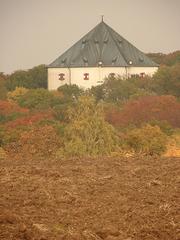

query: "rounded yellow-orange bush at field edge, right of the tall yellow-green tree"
left=125, top=124, right=167, bottom=155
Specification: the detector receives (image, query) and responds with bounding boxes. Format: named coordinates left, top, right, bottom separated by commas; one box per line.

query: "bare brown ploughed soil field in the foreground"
left=0, top=156, right=180, bottom=240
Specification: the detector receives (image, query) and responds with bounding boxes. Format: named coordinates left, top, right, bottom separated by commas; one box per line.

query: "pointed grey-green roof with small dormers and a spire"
left=48, top=21, right=158, bottom=68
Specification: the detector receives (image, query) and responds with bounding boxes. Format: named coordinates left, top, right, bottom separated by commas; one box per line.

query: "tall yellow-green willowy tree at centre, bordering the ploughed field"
left=60, top=96, right=118, bottom=156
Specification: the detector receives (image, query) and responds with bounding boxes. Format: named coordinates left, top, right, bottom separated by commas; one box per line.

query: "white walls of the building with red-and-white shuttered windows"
left=48, top=67, right=158, bottom=90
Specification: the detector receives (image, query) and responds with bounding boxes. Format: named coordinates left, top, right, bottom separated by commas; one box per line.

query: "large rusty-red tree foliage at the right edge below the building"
left=106, top=95, right=180, bottom=127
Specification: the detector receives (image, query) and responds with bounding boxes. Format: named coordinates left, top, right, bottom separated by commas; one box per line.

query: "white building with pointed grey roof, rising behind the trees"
left=48, top=19, right=158, bottom=90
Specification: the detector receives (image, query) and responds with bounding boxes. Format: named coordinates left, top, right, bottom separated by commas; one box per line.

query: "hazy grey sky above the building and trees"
left=0, top=0, right=180, bottom=73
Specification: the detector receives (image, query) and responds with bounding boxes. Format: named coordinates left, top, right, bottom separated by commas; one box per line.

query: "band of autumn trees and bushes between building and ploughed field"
left=0, top=50, right=180, bottom=158
